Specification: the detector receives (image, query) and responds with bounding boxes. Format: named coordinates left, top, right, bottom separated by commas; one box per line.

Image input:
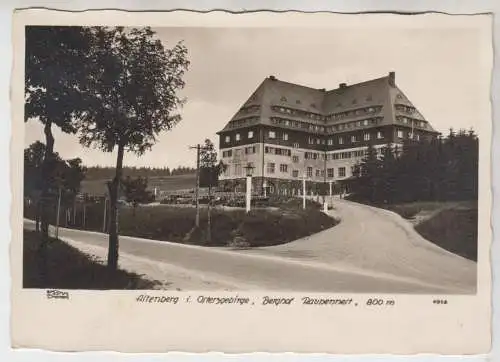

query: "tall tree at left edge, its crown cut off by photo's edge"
left=24, top=26, right=91, bottom=245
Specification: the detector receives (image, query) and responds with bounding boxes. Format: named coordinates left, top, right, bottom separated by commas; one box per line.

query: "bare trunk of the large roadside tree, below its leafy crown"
left=108, top=145, right=124, bottom=270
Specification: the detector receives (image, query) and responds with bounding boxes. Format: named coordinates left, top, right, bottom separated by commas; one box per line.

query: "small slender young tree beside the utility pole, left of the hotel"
left=200, top=138, right=227, bottom=242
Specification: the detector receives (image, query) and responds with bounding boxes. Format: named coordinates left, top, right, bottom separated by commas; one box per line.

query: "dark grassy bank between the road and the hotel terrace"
left=25, top=199, right=338, bottom=247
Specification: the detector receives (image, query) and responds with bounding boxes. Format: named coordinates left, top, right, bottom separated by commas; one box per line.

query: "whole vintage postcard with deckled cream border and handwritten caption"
left=11, top=9, right=493, bottom=354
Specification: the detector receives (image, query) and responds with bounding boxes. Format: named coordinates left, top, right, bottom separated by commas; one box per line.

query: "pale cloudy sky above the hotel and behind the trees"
left=25, top=19, right=490, bottom=168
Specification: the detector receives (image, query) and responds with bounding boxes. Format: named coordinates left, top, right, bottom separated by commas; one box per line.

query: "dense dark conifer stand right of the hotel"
left=350, top=130, right=479, bottom=204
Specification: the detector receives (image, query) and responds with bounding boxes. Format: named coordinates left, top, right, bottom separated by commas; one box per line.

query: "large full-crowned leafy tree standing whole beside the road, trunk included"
left=78, top=27, right=189, bottom=269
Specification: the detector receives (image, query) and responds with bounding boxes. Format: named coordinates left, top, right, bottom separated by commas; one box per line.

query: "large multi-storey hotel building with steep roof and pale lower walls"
left=218, top=72, right=437, bottom=195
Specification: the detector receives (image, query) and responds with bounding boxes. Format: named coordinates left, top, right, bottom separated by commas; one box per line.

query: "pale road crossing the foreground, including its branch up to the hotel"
left=25, top=197, right=476, bottom=294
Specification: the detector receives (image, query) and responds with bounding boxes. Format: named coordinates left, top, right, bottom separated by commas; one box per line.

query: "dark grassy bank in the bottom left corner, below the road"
left=23, top=230, right=159, bottom=290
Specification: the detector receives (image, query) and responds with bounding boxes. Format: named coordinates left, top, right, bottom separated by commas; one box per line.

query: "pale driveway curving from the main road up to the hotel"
left=236, top=199, right=477, bottom=293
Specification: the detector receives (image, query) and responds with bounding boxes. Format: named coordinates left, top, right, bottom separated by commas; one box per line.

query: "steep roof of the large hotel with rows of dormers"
left=219, top=72, right=434, bottom=131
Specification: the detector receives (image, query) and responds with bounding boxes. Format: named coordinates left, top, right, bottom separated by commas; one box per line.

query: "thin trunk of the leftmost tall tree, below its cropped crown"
left=40, top=121, right=54, bottom=244
